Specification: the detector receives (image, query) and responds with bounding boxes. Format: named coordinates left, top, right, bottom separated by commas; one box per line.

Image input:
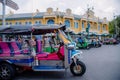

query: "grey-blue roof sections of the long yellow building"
left=0, top=11, right=108, bottom=23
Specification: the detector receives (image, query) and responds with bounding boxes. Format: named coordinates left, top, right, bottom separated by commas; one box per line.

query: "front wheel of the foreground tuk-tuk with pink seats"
left=70, top=61, right=86, bottom=76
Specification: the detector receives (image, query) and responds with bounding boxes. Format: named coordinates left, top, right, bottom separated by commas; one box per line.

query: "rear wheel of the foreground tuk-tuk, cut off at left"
left=0, top=63, right=15, bottom=80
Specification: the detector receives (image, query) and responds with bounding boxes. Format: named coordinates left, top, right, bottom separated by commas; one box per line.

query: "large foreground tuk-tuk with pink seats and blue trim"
left=0, top=25, right=86, bottom=80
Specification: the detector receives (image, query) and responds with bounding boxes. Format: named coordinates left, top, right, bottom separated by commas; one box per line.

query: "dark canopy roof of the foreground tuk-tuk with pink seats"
left=0, top=24, right=66, bottom=35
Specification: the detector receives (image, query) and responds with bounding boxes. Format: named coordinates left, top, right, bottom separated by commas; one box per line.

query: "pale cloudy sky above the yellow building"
left=0, top=0, right=120, bottom=21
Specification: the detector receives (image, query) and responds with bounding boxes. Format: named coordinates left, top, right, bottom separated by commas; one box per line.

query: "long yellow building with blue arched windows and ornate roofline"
left=0, top=8, right=109, bottom=35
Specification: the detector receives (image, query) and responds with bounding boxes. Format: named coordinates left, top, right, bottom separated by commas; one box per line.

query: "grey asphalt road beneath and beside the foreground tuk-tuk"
left=15, top=44, right=120, bottom=80
